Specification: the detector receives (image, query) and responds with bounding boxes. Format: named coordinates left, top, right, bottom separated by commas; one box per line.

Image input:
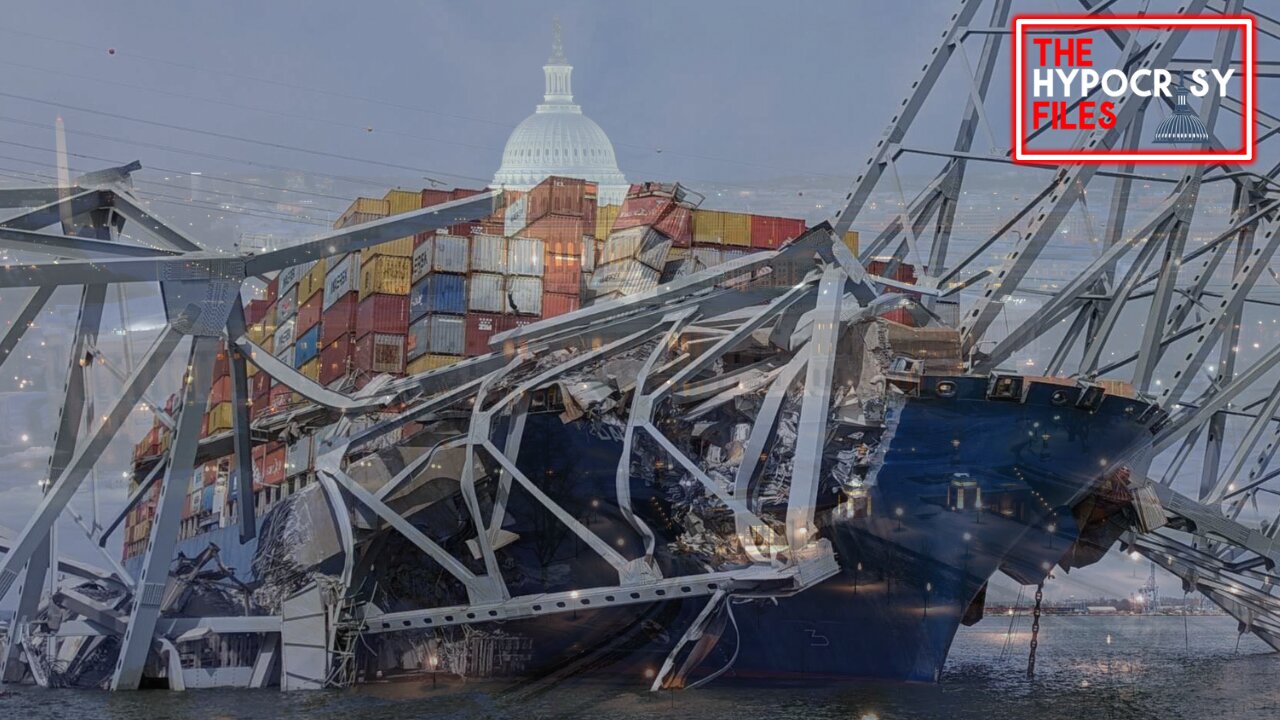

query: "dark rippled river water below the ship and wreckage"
left=0, top=616, right=1280, bottom=720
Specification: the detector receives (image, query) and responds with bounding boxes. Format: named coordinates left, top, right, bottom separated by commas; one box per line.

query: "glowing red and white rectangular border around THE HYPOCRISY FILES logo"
left=1011, top=15, right=1257, bottom=165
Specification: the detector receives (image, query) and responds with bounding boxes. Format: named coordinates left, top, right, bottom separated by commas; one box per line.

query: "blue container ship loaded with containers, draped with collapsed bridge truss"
left=97, top=177, right=1164, bottom=689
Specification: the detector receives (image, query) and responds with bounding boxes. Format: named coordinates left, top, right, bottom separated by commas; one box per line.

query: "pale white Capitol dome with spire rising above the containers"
left=493, top=23, right=627, bottom=205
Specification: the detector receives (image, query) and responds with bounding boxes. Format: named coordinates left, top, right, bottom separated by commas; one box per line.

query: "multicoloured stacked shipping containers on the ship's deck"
left=125, top=177, right=814, bottom=556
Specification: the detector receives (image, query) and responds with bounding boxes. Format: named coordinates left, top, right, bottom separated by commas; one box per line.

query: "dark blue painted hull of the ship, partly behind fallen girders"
left=358, top=378, right=1156, bottom=683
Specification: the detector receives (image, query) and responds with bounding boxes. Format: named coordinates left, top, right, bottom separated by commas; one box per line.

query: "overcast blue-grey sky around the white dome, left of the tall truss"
left=0, top=0, right=1249, bottom=604
